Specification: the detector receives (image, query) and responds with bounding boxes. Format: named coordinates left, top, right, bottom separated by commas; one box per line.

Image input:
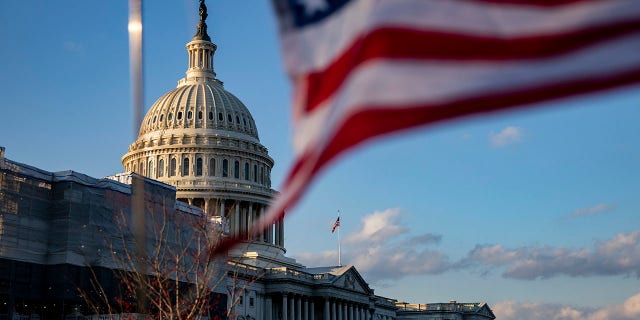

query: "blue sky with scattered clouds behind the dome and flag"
left=0, top=0, right=640, bottom=319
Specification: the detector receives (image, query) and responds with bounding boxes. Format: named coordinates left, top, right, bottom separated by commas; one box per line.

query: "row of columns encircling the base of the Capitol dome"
left=187, top=198, right=284, bottom=247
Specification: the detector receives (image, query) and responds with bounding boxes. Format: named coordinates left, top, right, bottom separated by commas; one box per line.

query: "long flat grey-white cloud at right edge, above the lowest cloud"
left=455, top=230, right=640, bottom=280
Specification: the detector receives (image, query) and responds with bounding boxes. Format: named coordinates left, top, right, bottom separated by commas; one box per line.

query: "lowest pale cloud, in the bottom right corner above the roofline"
left=491, top=293, right=640, bottom=320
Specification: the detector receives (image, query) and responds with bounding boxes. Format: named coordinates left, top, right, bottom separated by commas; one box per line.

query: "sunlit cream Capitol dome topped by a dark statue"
left=122, top=2, right=285, bottom=255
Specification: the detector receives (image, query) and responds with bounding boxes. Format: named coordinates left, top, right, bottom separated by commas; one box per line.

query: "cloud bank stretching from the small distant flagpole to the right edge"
left=295, top=208, right=640, bottom=283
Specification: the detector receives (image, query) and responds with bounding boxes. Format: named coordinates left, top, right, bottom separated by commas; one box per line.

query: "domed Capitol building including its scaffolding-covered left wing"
left=0, top=1, right=495, bottom=320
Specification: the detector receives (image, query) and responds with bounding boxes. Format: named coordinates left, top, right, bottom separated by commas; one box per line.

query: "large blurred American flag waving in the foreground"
left=211, top=0, right=640, bottom=254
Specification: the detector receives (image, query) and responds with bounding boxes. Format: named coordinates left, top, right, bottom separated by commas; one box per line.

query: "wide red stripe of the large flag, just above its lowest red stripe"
left=302, top=18, right=640, bottom=112
